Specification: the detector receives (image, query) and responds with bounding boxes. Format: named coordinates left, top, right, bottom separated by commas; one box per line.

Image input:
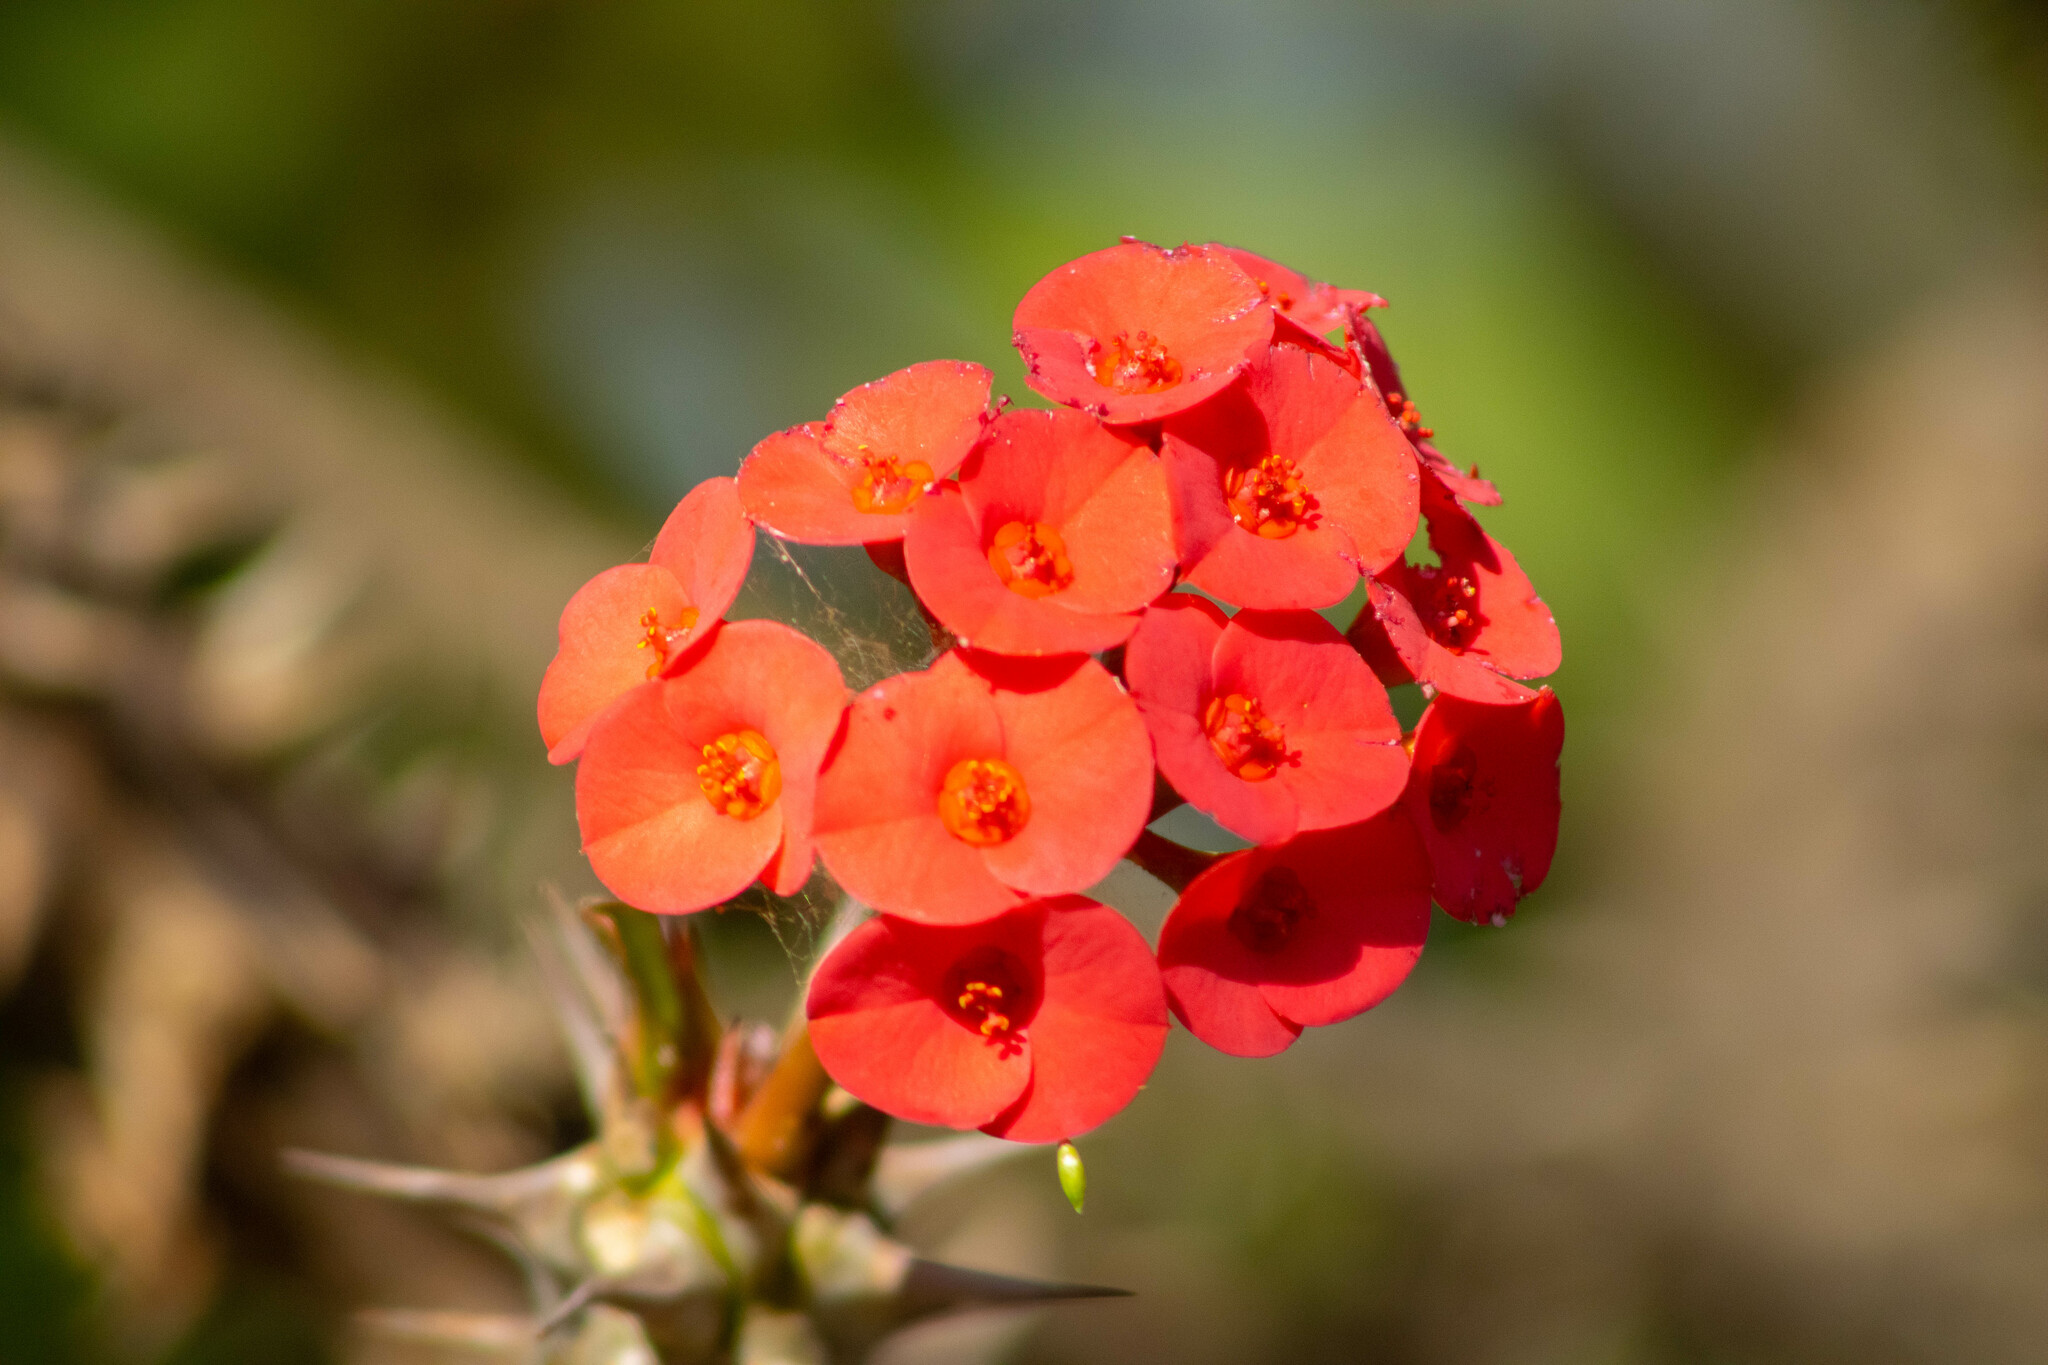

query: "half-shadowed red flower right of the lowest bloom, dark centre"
left=1159, top=810, right=1430, bottom=1056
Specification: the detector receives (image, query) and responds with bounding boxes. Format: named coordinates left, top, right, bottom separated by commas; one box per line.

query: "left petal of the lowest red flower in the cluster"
left=805, top=915, right=1024, bottom=1128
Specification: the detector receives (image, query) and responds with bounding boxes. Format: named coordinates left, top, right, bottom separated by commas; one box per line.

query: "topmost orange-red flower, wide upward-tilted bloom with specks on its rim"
left=1014, top=239, right=1274, bottom=422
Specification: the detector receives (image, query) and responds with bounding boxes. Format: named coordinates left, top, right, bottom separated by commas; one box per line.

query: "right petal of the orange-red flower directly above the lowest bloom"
left=971, top=655, right=1153, bottom=896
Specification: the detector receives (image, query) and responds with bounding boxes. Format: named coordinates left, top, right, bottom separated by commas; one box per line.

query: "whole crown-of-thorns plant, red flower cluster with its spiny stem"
left=297, top=239, right=1563, bottom=1365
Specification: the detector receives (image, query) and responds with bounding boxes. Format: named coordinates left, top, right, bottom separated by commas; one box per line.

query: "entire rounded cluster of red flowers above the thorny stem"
left=539, top=239, right=1565, bottom=1142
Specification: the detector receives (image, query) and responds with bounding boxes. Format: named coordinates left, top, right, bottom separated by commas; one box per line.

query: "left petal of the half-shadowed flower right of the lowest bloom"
left=1159, top=855, right=1300, bottom=1056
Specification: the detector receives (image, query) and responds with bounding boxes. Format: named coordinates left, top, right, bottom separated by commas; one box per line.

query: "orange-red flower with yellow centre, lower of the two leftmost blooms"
left=575, top=620, right=846, bottom=915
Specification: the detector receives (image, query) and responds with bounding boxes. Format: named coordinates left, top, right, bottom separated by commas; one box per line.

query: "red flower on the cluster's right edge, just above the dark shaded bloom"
left=1350, top=477, right=1563, bottom=704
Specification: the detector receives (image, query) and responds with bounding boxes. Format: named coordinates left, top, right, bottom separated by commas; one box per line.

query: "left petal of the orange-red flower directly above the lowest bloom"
left=815, top=653, right=1036, bottom=923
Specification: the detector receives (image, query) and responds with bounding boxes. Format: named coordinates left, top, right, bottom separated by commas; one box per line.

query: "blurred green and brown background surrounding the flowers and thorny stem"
left=0, top=0, right=2048, bottom=1365
